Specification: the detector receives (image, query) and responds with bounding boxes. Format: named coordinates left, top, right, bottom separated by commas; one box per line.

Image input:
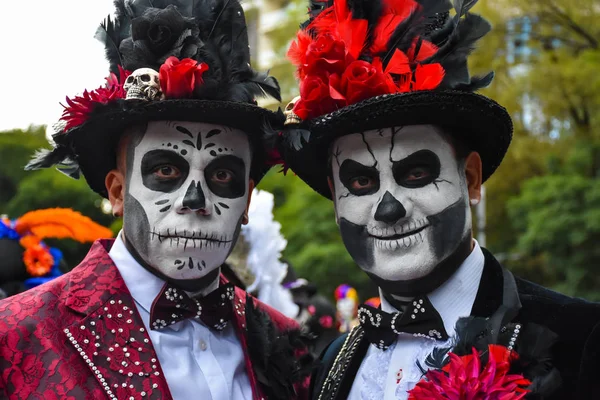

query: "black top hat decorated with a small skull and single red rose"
left=26, top=0, right=283, bottom=197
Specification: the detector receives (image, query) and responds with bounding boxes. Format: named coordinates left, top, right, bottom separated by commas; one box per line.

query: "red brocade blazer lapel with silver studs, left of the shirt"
left=64, top=241, right=171, bottom=399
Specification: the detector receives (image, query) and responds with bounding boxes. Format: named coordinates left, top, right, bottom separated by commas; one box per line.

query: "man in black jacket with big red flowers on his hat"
left=280, top=0, right=600, bottom=400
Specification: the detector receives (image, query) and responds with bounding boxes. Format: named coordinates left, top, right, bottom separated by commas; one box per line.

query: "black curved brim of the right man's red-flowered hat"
left=281, top=90, right=513, bottom=199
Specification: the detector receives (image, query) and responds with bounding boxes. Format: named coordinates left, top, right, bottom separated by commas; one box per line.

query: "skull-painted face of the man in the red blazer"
left=124, top=121, right=251, bottom=280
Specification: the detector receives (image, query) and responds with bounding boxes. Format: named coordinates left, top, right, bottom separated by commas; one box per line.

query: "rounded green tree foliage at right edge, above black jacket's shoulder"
left=509, top=144, right=600, bottom=300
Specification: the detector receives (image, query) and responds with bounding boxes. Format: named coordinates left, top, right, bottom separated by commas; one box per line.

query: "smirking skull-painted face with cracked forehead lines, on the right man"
left=331, top=125, right=471, bottom=282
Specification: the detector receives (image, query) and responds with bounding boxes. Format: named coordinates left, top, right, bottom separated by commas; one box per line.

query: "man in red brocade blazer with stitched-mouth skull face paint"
left=0, top=0, right=310, bottom=400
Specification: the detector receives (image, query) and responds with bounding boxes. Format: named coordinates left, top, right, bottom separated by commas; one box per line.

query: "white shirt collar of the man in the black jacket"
left=380, top=239, right=485, bottom=336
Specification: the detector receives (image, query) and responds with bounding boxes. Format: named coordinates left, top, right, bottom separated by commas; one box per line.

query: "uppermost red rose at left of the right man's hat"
left=301, top=35, right=346, bottom=75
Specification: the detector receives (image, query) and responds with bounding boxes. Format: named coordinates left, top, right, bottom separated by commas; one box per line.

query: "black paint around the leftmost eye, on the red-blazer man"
left=141, top=150, right=190, bottom=193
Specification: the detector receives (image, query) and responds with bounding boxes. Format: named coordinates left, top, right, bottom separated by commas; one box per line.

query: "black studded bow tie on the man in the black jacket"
left=358, top=296, right=448, bottom=350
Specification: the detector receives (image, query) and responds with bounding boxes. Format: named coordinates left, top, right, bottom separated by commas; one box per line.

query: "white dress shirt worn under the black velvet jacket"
left=348, top=241, right=485, bottom=400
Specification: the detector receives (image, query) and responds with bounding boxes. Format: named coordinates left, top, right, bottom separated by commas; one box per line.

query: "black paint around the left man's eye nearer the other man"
left=204, top=155, right=246, bottom=199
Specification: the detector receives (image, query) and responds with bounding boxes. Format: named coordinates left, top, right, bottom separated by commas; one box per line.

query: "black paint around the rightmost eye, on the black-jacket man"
left=392, top=150, right=441, bottom=189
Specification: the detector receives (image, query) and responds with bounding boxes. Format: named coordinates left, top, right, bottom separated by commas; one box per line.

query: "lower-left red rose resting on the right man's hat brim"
left=294, top=75, right=345, bottom=120
